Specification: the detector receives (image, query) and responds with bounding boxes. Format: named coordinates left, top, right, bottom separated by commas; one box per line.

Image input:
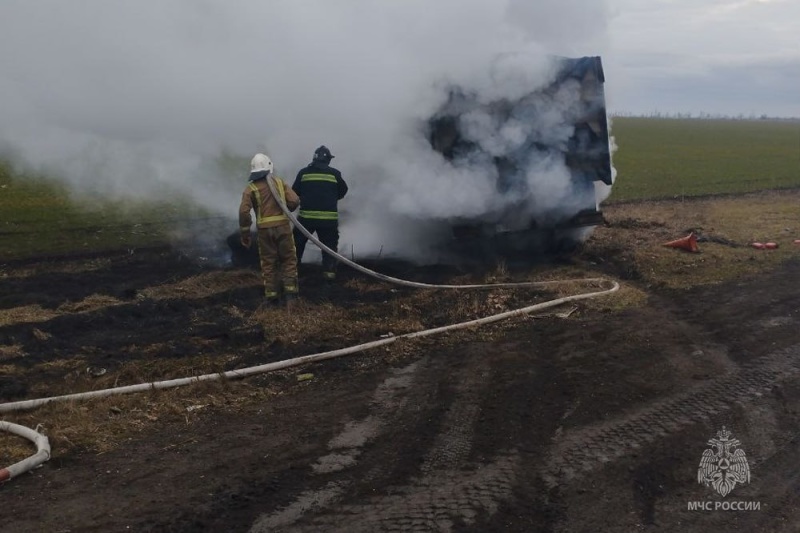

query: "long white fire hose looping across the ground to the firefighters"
left=0, top=179, right=619, bottom=482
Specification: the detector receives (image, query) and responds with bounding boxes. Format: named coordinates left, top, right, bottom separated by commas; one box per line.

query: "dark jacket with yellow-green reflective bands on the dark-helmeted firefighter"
left=292, top=161, right=347, bottom=225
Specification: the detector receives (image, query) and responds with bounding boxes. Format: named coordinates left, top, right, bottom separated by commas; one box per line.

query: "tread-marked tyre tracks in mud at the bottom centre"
left=251, top=357, right=519, bottom=532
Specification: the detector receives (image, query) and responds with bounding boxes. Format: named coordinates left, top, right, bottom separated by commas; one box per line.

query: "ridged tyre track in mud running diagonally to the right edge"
left=542, top=344, right=800, bottom=487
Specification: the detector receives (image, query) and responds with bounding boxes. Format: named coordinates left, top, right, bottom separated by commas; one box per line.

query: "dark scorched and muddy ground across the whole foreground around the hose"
left=0, top=230, right=800, bottom=532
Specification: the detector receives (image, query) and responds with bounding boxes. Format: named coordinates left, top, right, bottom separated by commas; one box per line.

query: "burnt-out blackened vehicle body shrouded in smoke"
left=427, top=57, right=613, bottom=258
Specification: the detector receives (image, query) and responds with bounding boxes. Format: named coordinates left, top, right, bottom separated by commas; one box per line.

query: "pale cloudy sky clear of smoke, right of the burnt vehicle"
left=604, top=0, right=800, bottom=117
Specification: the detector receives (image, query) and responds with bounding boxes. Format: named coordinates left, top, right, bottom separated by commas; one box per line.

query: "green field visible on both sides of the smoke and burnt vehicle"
left=0, top=118, right=800, bottom=263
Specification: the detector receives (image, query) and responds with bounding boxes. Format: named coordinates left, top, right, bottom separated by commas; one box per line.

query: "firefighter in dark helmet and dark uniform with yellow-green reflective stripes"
left=292, top=146, right=347, bottom=281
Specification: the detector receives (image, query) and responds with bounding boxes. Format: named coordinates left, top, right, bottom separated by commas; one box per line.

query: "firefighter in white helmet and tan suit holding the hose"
left=239, top=154, right=300, bottom=307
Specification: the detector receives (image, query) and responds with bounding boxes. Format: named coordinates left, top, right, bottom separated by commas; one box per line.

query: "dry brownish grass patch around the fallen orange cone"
left=587, top=190, right=800, bottom=289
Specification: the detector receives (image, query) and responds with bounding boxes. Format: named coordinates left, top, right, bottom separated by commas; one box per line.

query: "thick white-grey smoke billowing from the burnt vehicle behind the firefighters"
left=0, top=0, right=607, bottom=262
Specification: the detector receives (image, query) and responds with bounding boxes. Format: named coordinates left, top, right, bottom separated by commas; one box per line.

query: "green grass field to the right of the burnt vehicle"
left=609, top=117, right=800, bottom=202
